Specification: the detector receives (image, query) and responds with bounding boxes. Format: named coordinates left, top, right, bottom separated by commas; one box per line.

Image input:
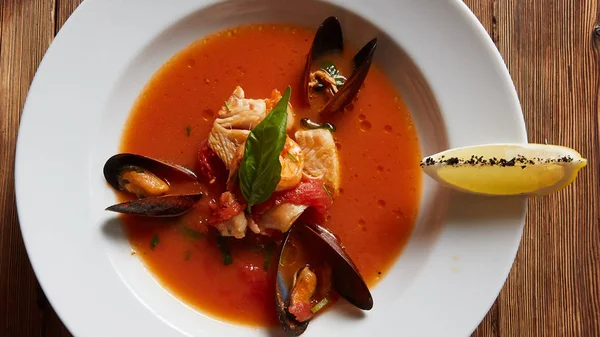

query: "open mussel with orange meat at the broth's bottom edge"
left=275, top=223, right=373, bottom=336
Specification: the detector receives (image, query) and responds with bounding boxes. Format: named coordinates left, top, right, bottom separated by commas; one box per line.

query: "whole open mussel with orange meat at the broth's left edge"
left=104, top=153, right=202, bottom=217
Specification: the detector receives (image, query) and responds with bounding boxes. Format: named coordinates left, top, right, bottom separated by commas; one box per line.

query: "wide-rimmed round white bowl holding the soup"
left=16, top=0, right=527, bottom=337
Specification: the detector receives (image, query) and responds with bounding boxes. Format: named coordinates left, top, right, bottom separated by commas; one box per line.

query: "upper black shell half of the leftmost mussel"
left=104, top=153, right=198, bottom=190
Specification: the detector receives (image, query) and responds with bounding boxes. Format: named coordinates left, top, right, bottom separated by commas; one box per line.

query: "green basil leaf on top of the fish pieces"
left=238, top=86, right=292, bottom=211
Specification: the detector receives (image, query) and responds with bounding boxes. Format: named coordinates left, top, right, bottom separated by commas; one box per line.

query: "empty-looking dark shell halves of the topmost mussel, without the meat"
left=302, top=16, right=377, bottom=117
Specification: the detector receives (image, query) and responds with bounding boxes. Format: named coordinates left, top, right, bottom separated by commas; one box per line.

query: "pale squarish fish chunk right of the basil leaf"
left=295, top=129, right=340, bottom=195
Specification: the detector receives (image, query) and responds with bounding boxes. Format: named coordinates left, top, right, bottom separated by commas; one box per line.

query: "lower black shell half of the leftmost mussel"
left=106, top=193, right=203, bottom=217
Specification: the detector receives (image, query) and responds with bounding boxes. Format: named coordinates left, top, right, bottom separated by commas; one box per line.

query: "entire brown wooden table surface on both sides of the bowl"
left=0, top=0, right=600, bottom=337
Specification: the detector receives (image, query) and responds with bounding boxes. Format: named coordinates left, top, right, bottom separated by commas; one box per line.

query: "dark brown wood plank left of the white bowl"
left=0, top=0, right=76, bottom=337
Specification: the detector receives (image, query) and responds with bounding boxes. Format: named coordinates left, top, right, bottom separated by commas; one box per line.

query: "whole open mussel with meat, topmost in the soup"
left=302, top=16, right=377, bottom=117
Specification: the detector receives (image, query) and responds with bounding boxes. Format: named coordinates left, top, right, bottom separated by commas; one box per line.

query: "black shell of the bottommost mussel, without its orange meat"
left=275, top=224, right=373, bottom=336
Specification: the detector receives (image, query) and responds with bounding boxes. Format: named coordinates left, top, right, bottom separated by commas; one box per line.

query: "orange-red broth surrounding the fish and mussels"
left=120, top=24, right=421, bottom=326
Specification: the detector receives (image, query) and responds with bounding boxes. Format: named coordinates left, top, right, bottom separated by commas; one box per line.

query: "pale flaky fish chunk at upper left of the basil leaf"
left=208, top=86, right=294, bottom=170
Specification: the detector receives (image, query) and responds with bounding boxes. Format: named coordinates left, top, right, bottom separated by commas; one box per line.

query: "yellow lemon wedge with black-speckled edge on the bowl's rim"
left=421, top=144, right=587, bottom=196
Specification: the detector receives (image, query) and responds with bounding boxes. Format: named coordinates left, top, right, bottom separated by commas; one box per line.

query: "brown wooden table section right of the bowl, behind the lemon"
left=466, top=0, right=600, bottom=337
